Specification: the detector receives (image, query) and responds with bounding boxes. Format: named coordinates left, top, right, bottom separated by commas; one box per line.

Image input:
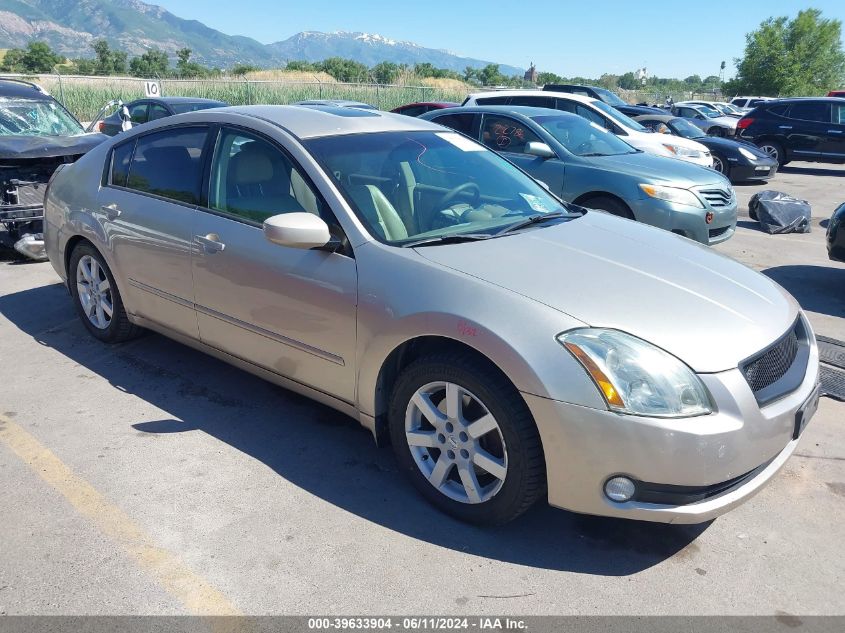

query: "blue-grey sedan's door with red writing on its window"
left=480, top=114, right=565, bottom=195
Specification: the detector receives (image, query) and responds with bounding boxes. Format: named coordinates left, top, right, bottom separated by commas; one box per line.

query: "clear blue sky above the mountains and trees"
left=155, top=0, right=845, bottom=78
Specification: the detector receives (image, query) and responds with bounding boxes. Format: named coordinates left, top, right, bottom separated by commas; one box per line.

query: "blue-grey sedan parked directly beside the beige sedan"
left=422, top=106, right=737, bottom=244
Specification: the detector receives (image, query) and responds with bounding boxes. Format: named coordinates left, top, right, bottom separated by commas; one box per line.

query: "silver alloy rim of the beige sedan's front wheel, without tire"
left=405, top=382, right=508, bottom=504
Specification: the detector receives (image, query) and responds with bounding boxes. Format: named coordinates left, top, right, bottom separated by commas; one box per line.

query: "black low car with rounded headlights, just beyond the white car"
left=636, top=114, right=778, bottom=182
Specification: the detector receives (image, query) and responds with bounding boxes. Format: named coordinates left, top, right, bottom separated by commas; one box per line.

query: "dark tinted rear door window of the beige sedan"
left=126, top=127, right=207, bottom=204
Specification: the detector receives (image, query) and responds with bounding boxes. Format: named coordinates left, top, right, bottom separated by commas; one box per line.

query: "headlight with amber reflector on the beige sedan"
left=557, top=328, right=713, bottom=418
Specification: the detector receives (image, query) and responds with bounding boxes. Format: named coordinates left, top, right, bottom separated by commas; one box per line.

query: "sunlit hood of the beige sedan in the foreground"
left=417, top=211, right=799, bottom=373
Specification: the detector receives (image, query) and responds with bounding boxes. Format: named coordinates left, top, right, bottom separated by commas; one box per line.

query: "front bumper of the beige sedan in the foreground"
left=523, top=344, right=819, bottom=523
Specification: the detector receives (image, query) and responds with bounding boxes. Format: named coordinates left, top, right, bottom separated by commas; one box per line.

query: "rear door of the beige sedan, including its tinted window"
left=94, top=125, right=208, bottom=338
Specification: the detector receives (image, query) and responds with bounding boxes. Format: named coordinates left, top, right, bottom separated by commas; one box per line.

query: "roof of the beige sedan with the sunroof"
left=175, top=105, right=443, bottom=139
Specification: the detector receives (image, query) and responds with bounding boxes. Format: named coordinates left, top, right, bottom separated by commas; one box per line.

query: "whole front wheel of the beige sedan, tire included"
left=388, top=353, right=546, bottom=525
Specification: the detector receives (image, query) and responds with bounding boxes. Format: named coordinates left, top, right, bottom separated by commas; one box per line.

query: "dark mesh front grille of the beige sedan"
left=739, top=318, right=809, bottom=404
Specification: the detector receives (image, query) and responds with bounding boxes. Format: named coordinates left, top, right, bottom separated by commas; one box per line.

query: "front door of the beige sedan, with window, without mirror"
left=192, top=128, right=357, bottom=403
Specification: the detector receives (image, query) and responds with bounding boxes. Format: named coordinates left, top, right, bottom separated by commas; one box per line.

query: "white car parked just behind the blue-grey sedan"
left=461, top=90, right=713, bottom=167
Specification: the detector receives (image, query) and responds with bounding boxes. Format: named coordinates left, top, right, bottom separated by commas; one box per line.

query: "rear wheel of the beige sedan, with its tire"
left=68, top=243, right=140, bottom=343
